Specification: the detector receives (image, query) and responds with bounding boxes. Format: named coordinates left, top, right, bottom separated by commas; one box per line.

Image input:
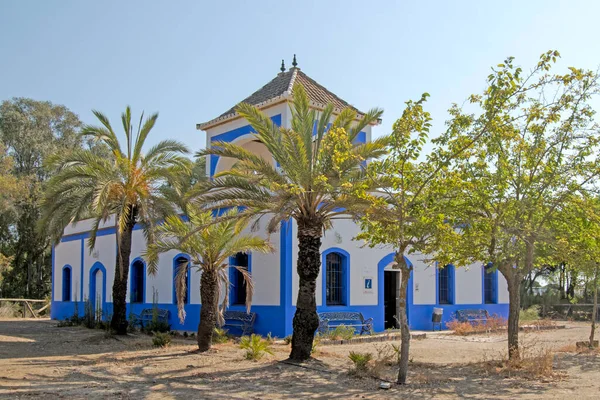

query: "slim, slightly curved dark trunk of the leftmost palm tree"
left=110, top=210, right=135, bottom=335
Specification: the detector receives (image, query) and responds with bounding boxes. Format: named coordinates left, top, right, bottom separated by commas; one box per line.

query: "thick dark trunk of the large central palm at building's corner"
left=290, top=221, right=326, bottom=361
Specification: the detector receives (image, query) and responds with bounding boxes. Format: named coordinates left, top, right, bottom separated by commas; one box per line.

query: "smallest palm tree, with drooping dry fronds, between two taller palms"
left=144, top=208, right=273, bottom=352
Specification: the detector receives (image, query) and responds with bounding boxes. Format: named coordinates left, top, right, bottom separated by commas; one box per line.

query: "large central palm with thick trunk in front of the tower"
left=197, top=84, right=387, bottom=360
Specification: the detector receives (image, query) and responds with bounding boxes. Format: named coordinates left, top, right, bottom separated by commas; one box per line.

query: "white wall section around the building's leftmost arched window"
left=53, top=240, right=81, bottom=301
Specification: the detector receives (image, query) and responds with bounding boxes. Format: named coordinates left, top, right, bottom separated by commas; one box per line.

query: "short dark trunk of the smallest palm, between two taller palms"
left=198, top=270, right=219, bottom=352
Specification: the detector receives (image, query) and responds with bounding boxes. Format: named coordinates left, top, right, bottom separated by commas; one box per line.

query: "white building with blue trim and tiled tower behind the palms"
left=51, top=63, right=508, bottom=337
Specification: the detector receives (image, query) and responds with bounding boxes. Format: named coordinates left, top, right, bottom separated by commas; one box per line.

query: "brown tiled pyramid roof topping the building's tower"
left=197, top=68, right=364, bottom=129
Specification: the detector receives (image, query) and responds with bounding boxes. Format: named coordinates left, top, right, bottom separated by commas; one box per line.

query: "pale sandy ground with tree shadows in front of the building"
left=0, top=319, right=600, bottom=400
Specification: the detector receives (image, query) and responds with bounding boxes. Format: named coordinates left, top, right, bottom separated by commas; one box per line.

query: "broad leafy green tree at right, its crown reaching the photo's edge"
left=440, top=51, right=600, bottom=359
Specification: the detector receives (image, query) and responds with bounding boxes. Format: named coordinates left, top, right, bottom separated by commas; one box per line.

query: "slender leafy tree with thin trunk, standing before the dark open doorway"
left=357, top=93, right=468, bottom=384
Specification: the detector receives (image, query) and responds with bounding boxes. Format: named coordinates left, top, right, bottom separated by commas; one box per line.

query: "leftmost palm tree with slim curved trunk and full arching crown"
left=42, top=107, right=189, bottom=335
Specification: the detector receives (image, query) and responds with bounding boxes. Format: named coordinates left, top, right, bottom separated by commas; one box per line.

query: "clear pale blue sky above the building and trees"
left=0, top=0, right=600, bottom=154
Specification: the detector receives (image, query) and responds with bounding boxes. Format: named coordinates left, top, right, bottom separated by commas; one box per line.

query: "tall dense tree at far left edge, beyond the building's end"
left=0, top=98, right=83, bottom=298
